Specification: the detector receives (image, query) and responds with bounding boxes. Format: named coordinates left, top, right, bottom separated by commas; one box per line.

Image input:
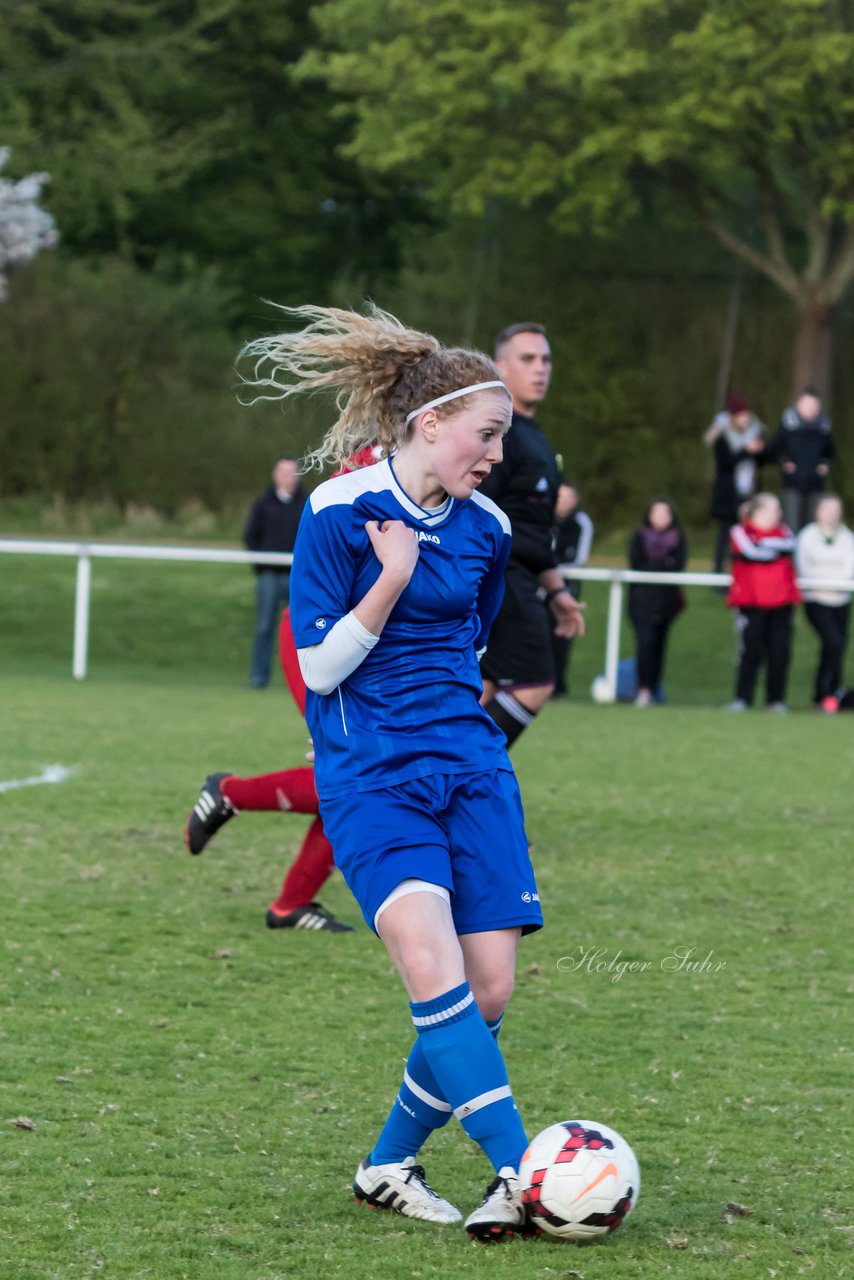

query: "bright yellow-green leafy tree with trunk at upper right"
left=303, top=0, right=854, bottom=384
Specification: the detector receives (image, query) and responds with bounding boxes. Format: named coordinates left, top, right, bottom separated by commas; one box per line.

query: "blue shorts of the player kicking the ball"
left=320, top=771, right=543, bottom=934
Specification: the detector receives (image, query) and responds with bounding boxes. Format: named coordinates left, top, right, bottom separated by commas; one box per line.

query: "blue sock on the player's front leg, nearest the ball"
left=410, top=982, right=528, bottom=1170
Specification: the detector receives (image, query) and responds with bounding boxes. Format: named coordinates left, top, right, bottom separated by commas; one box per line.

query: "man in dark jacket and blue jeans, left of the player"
left=243, top=458, right=306, bottom=689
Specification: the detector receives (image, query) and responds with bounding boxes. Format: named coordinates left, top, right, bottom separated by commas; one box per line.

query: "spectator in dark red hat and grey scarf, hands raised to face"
left=703, top=396, right=764, bottom=573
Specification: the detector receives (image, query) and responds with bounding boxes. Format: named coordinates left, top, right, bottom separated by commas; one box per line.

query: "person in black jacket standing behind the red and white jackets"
left=766, top=387, right=834, bottom=534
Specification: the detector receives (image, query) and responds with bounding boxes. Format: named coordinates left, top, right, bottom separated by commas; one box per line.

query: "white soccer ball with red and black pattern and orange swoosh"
left=519, top=1120, right=640, bottom=1240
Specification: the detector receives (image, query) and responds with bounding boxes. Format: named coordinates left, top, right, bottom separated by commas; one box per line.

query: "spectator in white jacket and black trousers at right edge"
left=796, top=494, right=854, bottom=714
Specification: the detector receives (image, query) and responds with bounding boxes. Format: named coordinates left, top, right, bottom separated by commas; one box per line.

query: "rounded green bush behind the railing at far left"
left=0, top=256, right=320, bottom=515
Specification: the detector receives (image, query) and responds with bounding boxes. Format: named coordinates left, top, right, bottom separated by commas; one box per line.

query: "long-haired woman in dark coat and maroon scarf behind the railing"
left=629, top=498, right=688, bottom=707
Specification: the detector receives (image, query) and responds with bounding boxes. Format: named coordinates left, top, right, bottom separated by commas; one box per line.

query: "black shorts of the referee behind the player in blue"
left=480, top=561, right=554, bottom=689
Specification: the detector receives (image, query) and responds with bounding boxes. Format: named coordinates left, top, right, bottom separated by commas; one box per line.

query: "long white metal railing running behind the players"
left=0, top=538, right=854, bottom=701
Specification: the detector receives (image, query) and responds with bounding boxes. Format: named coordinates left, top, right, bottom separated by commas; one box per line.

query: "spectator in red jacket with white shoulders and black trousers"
left=727, top=493, right=800, bottom=713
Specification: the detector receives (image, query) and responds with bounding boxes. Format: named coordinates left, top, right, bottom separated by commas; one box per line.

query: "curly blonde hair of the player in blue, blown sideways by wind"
left=238, top=305, right=501, bottom=467
